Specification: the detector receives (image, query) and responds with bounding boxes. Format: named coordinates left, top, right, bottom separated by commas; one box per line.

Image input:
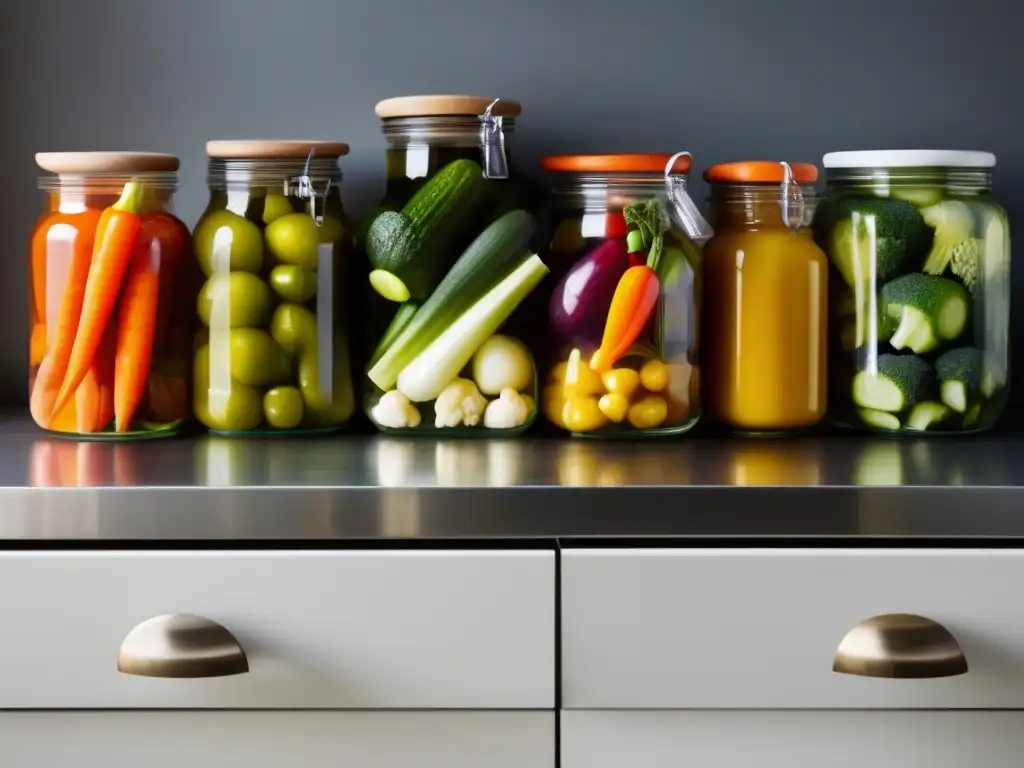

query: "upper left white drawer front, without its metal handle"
left=0, top=551, right=555, bottom=709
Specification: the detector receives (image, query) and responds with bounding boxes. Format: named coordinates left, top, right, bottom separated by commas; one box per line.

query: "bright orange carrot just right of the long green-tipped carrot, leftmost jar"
left=114, top=242, right=160, bottom=432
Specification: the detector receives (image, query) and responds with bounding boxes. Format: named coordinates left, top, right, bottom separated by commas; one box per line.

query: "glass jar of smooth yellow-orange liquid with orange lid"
left=700, top=162, right=828, bottom=433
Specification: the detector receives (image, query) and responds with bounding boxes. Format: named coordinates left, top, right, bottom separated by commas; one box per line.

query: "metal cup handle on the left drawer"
left=118, top=613, right=249, bottom=678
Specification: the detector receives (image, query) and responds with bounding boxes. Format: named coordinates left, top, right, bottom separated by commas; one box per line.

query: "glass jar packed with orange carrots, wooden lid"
left=29, top=152, right=196, bottom=439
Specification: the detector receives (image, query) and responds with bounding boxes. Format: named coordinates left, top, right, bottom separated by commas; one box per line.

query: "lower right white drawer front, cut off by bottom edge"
left=561, top=710, right=1024, bottom=768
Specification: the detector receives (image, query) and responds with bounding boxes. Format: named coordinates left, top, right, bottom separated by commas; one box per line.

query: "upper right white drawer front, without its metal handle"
left=561, top=550, right=1024, bottom=709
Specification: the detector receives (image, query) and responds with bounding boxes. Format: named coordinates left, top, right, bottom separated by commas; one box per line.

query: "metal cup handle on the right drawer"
left=833, top=613, right=967, bottom=679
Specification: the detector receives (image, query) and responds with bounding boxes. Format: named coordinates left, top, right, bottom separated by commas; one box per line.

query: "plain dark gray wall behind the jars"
left=0, top=0, right=1024, bottom=402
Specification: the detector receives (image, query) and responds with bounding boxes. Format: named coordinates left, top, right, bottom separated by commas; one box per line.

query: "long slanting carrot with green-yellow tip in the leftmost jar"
left=54, top=181, right=144, bottom=411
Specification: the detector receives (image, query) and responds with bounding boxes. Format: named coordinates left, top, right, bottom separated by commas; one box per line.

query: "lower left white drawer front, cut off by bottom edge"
left=0, top=712, right=555, bottom=768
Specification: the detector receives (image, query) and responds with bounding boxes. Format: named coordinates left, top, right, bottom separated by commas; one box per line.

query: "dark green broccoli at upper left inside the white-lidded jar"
left=824, top=198, right=932, bottom=295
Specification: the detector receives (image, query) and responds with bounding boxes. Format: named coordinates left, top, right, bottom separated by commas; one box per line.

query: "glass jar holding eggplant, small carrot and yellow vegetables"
left=535, top=154, right=711, bottom=436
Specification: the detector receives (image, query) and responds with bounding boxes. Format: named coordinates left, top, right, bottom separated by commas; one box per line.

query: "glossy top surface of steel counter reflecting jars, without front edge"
left=0, top=411, right=1024, bottom=488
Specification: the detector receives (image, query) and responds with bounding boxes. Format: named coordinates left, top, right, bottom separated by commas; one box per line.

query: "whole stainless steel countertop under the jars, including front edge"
left=0, top=413, right=1024, bottom=546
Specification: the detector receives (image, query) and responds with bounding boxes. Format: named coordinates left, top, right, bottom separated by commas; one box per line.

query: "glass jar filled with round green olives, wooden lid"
left=193, top=141, right=355, bottom=434
